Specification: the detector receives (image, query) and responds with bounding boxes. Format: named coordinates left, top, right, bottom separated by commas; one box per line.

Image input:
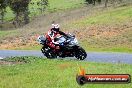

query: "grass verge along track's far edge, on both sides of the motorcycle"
left=14, top=44, right=132, bottom=53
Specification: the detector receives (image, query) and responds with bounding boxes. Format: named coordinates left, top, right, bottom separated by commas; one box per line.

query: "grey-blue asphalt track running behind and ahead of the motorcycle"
left=0, top=50, right=132, bottom=64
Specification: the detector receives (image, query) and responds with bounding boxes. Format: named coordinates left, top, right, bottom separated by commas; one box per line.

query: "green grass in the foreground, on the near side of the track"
left=0, top=57, right=132, bottom=88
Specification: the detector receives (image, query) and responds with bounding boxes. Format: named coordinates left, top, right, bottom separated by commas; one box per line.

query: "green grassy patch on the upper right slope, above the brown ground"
left=71, top=6, right=132, bottom=27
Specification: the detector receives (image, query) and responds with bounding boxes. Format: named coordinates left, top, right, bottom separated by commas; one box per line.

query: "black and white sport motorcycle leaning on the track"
left=37, top=34, right=87, bottom=60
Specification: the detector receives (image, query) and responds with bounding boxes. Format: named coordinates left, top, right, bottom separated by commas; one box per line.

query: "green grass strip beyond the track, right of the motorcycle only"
left=80, top=41, right=132, bottom=53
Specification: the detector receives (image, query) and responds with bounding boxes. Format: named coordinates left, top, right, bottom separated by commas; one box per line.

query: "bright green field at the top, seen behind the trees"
left=5, top=0, right=84, bottom=20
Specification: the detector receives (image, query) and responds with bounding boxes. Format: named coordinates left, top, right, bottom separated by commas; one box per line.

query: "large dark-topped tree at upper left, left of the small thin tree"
left=9, top=0, right=30, bottom=26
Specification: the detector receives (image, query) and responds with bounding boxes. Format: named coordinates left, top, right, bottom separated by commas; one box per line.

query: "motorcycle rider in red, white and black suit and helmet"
left=46, top=24, right=68, bottom=50
